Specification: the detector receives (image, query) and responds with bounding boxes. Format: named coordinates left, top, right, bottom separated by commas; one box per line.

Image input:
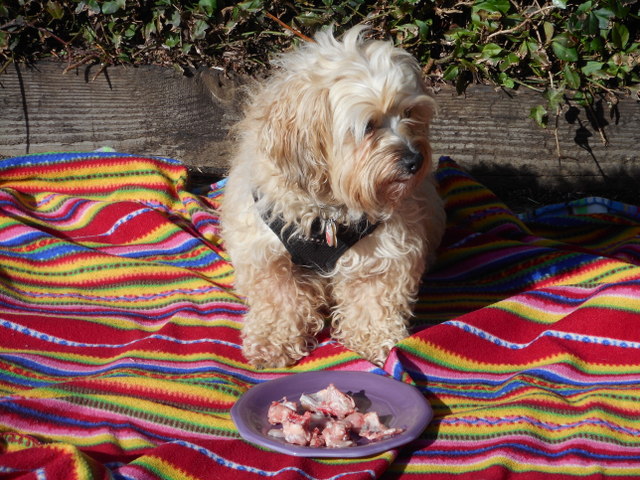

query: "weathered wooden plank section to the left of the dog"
left=0, top=61, right=238, bottom=168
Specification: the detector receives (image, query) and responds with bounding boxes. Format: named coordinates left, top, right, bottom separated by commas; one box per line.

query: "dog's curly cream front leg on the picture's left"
left=242, top=257, right=324, bottom=368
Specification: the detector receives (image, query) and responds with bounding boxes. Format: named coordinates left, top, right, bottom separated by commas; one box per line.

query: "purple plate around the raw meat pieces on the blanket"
left=231, top=371, right=433, bottom=458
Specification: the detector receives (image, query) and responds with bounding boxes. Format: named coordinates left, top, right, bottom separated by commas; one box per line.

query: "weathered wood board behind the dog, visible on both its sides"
left=0, top=61, right=640, bottom=206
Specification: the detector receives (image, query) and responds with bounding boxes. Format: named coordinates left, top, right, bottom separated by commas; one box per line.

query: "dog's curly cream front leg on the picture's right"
left=332, top=272, right=416, bottom=366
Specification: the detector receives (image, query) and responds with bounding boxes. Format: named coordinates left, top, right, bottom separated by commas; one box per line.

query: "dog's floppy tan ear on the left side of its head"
left=259, top=78, right=333, bottom=193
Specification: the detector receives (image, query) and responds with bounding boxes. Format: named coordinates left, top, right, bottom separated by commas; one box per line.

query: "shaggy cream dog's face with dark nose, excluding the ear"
left=328, top=66, right=433, bottom=217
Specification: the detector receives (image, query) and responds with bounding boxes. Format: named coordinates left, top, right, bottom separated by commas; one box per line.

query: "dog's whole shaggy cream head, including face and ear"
left=254, top=27, right=435, bottom=219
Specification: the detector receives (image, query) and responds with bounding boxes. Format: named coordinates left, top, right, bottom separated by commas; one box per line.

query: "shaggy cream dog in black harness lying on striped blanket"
left=220, top=26, right=445, bottom=368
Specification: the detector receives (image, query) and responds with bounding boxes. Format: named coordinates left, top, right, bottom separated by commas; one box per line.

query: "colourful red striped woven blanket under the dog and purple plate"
left=0, top=153, right=640, bottom=480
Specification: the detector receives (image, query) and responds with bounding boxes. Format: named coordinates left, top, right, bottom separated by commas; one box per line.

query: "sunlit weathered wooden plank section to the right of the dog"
left=432, top=81, right=640, bottom=178
